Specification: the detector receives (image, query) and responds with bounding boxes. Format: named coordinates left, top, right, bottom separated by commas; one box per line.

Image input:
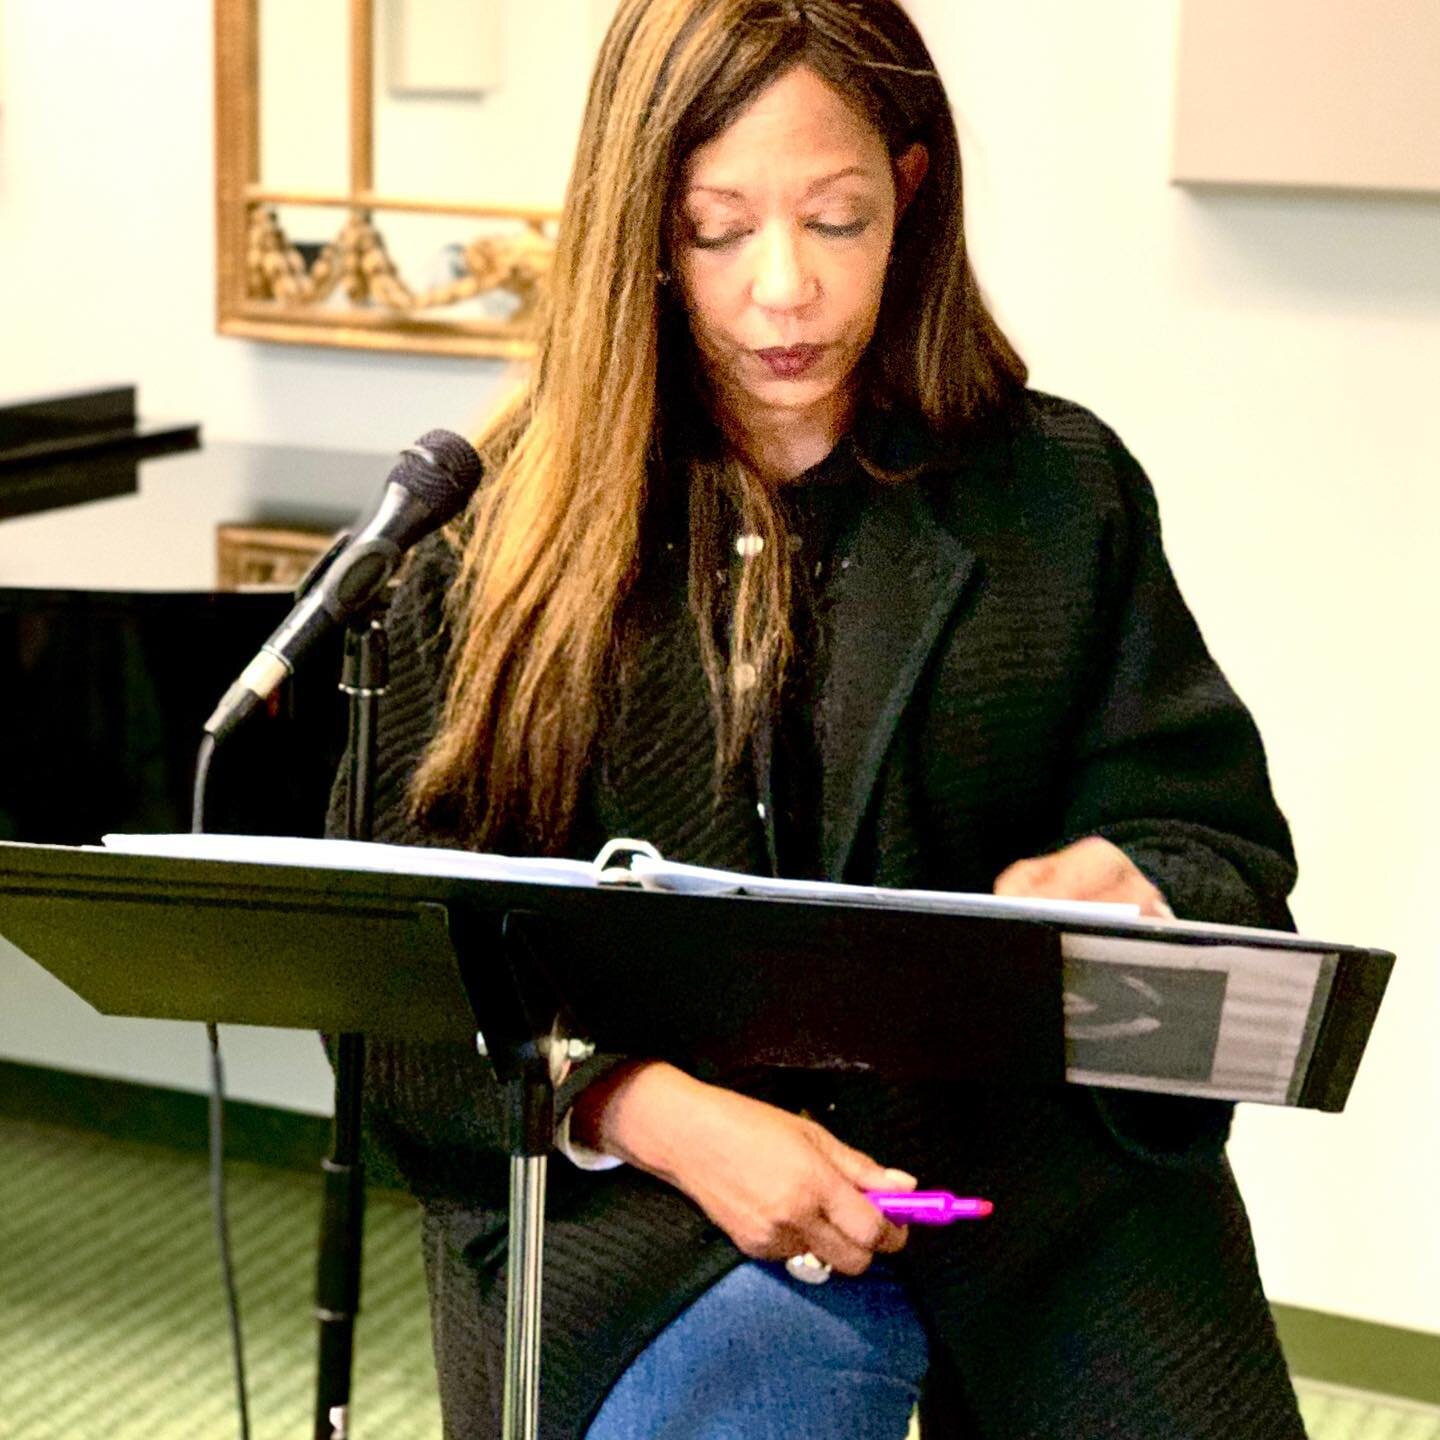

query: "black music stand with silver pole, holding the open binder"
left=0, top=844, right=1394, bottom=1440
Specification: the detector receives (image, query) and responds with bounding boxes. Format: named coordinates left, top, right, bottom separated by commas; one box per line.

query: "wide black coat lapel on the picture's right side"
left=816, top=481, right=975, bottom=880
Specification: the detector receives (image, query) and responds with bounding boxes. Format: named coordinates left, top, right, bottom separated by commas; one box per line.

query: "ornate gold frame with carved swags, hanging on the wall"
left=215, top=0, right=557, bottom=359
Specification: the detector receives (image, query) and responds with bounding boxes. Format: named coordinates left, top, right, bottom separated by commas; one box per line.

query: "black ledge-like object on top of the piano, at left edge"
left=0, top=386, right=200, bottom=520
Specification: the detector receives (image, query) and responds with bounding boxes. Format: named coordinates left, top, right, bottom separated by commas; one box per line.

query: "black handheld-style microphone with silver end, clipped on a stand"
left=204, top=431, right=480, bottom=740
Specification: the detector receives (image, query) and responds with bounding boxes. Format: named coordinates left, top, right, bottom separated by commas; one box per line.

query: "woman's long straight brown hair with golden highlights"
left=412, top=0, right=1025, bottom=848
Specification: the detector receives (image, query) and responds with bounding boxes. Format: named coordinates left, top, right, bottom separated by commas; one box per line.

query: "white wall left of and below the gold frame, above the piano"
left=0, top=0, right=506, bottom=452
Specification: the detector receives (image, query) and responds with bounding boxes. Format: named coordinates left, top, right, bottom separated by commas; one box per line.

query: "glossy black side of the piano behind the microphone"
left=0, top=589, right=344, bottom=845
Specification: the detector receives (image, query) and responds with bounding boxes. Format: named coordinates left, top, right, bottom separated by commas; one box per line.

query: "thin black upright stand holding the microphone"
left=314, top=600, right=389, bottom=1440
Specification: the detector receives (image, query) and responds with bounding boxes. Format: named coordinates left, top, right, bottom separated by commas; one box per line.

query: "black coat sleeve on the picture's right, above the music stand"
left=1064, top=420, right=1295, bottom=929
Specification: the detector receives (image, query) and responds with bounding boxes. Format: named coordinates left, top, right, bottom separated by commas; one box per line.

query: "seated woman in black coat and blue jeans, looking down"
left=342, top=0, right=1303, bottom=1440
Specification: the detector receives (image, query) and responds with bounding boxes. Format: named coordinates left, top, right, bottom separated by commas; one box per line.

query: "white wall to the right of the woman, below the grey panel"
left=910, top=0, right=1440, bottom=1331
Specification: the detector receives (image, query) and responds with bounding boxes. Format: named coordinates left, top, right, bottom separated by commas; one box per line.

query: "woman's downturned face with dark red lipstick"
left=674, top=66, right=924, bottom=440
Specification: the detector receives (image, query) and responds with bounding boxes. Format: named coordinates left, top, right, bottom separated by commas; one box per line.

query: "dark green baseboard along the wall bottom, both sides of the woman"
left=0, top=1060, right=1440, bottom=1405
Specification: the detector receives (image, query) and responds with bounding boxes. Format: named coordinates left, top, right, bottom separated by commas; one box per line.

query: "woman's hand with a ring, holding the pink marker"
left=570, top=1061, right=916, bottom=1274
